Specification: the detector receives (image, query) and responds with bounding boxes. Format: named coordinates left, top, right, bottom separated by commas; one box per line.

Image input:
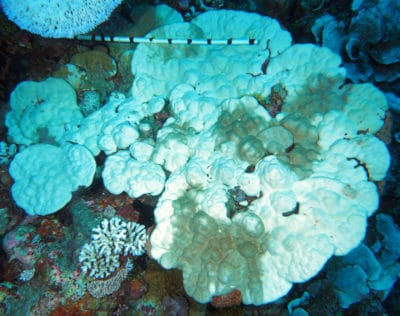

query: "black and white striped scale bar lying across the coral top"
left=75, top=35, right=257, bottom=45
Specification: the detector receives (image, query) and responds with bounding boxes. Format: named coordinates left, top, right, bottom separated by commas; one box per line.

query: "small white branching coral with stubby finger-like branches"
left=79, top=217, right=147, bottom=279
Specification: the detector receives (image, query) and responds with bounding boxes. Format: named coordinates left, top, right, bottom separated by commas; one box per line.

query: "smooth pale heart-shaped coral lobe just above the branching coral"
left=10, top=144, right=96, bottom=216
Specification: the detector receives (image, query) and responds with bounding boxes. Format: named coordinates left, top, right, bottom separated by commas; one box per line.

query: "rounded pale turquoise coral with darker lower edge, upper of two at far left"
left=5, top=77, right=83, bottom=145
